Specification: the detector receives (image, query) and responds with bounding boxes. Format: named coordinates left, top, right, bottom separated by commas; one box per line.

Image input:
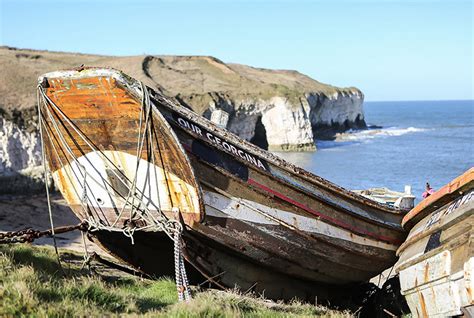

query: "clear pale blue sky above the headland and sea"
left=0, top=0, right=474, bottom=100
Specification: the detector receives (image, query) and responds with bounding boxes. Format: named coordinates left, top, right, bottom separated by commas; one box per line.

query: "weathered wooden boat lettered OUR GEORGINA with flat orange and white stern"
left=39, top=68, right=406, bottom=300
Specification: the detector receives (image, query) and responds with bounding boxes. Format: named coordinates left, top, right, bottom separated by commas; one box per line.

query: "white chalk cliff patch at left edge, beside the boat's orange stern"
left=0, top=117, right=41, bottom=175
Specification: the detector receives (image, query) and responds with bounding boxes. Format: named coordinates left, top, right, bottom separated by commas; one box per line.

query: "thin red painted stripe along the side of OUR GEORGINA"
left=248, top=179, right=402, bottom=245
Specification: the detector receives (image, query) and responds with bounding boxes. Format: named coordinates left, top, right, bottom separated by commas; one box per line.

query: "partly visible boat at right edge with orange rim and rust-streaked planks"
left=396, top=168, right=474, bottom=317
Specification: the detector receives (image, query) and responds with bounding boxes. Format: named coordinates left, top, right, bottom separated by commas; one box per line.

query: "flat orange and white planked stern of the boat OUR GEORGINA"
left=41, top=71, right=202, bottom=228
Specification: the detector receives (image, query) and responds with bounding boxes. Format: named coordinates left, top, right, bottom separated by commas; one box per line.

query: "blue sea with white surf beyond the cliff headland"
left=276, top=100, right=474, bottom=201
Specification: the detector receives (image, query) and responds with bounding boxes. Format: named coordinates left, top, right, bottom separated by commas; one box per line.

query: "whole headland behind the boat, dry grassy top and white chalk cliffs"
left=0, top=47, right=365, bottom=192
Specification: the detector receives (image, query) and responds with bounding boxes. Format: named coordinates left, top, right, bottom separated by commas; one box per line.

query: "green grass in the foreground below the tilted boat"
left=0, top=244, right=350, bottom=317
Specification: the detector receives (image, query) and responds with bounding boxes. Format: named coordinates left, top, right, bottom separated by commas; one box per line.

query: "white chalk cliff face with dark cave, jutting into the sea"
left=209, top=91, right=365, bottom=151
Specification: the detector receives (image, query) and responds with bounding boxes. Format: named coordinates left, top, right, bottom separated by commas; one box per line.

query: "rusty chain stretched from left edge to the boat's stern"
left=0, top=222, right=87, bottom=244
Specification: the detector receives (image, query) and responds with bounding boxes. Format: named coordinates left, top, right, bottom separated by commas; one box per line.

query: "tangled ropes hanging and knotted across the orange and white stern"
left=38, top=82, right=191, bottom=301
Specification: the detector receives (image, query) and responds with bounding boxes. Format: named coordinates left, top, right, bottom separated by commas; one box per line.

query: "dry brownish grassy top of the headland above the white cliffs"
left=0, top=46, right=359, bottom=114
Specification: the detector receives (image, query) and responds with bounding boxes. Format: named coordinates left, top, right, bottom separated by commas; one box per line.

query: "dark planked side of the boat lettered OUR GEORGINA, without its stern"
left=150, top=91, right=405, bottom=289
